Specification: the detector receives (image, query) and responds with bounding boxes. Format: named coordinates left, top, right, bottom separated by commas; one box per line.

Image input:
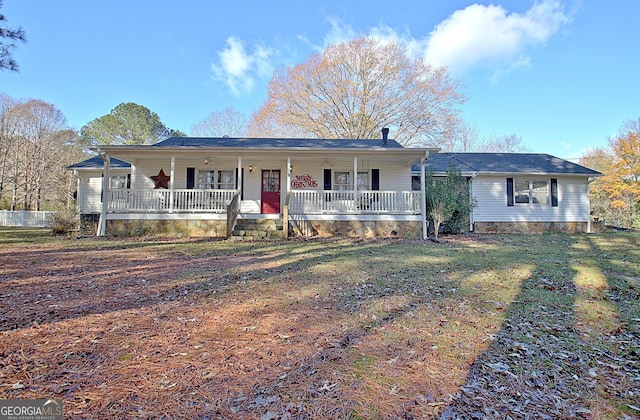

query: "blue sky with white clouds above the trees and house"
left=0, top=0, right=640, bottom=159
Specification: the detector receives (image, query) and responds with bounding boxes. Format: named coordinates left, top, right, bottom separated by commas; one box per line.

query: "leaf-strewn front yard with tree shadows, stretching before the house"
left=0, top=228, right=640, bottom=419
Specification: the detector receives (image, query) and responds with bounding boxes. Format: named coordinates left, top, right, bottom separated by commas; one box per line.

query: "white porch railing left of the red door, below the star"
left=108, top=189, right=236, bottom=213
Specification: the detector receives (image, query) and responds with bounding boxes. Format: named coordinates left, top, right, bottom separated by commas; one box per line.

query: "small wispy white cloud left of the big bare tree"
left=211, top=37, right=273, bottom=96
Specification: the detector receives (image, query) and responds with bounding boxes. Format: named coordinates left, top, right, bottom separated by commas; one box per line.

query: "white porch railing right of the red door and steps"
left=289, top=190, right=421, bottom=214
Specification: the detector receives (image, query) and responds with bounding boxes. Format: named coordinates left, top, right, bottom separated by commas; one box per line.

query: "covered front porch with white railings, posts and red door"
left=90, top=138, right=429, bottom=238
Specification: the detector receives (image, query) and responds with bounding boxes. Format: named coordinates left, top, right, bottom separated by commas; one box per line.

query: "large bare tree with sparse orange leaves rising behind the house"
left=249, top=38, right=464, bottom=146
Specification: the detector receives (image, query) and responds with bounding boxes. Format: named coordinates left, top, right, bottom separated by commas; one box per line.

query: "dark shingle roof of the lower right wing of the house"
left=414, top=152, right=601, bottom=176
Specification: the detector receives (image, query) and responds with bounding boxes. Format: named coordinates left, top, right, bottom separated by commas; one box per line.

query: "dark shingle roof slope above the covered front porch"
left=154, top=137, right=403, bottom=149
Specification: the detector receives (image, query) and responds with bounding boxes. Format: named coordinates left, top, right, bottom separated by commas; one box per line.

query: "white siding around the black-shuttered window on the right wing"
left=472, top=175, right=589, bottom=222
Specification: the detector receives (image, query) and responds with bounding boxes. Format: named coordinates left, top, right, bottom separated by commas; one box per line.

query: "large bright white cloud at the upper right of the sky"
left=424, top=0, right=570, bottom=74
